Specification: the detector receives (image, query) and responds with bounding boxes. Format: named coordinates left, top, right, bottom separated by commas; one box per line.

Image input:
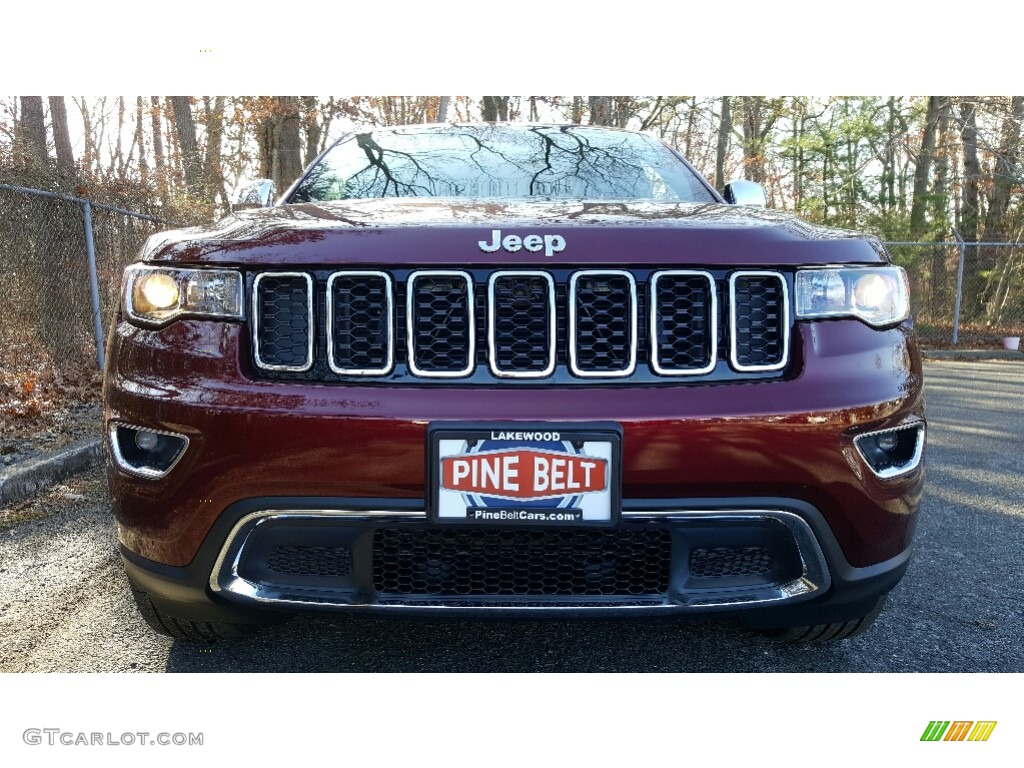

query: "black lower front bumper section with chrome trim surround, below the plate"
left=123, top=498, right=909, bottom=623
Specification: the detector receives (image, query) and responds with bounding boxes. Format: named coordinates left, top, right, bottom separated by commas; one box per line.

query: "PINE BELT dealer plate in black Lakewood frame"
left=427, top=423, right=622, bottom=526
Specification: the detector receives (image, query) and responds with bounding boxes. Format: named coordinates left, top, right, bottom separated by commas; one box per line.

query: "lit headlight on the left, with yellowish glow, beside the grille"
left=123, top=264, right=243, bottom=326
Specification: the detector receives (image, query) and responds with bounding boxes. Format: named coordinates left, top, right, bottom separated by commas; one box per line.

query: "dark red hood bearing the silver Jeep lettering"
left=142, top=198, right=888, bottom=266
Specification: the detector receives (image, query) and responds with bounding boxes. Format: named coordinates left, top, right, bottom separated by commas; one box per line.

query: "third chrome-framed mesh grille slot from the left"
left=409, top=273, right=473, bottom=374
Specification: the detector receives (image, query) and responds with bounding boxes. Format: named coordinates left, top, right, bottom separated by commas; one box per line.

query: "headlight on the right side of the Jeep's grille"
left=797, top=266, right=910, bottom=328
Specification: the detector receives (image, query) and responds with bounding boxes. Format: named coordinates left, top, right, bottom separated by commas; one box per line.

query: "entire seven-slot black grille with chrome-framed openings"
left=252, top=269, right=790, bottom=382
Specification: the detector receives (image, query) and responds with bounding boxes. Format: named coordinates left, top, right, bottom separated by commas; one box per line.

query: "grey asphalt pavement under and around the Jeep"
left=0, top=360, right=1024, bottom=672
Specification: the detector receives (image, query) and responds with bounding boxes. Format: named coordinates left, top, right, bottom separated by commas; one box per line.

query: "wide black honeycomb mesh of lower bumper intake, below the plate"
left=374, top=528, right=671, bottom=596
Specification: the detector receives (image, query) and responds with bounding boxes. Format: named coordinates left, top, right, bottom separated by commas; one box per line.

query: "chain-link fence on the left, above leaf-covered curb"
left=0, top=183, right=164, bottom=448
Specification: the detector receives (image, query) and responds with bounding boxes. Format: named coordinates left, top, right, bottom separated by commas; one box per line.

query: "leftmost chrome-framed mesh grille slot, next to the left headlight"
left=255, top=274, right=312, bottom=369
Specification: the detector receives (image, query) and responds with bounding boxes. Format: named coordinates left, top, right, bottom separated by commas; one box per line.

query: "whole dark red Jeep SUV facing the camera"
left=103, top=124, right=925, bottom=640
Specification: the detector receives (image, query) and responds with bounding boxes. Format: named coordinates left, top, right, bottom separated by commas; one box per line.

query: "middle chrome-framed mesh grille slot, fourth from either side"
left=490, top=274, right=556, bottom=374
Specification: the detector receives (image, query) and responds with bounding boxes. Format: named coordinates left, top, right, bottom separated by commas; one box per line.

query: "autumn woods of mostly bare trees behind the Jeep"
left=0, top=95, right=1024, bottom=436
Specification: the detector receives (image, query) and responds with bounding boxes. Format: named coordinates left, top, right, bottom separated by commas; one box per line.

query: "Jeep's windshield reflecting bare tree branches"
left=289, top=124, right=715, bottom=203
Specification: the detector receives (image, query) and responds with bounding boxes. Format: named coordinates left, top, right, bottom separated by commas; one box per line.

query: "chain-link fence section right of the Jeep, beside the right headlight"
left=886, top=241, right=1024, bottom=347
